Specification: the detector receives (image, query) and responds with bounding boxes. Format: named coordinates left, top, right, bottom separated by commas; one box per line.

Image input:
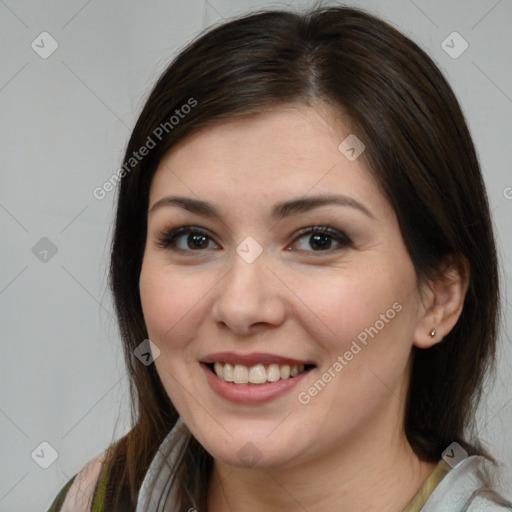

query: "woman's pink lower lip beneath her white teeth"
left=200, top=363, right=313, bottom=404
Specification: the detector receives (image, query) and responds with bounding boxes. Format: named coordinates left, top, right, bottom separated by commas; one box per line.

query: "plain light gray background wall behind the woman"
left=0, top=0, right=512, bottom=512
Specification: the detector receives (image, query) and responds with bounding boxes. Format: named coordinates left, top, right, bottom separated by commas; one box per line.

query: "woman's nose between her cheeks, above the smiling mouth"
left=212, top=251, right=286, bottom=335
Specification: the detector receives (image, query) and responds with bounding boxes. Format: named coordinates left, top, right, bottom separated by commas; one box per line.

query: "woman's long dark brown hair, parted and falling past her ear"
left=102, top=7, right=499, bottom=512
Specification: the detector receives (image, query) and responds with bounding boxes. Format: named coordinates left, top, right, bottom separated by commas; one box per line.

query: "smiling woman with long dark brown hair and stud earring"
left=47, top=7, right=512, bottom=512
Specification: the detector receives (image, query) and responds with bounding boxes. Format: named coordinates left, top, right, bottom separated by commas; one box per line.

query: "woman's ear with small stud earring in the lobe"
left=413, top=257, right=469, bottom=348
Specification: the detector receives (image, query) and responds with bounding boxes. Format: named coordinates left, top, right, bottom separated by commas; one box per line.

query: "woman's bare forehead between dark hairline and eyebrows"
left=150, top=104, right=384, bottom=217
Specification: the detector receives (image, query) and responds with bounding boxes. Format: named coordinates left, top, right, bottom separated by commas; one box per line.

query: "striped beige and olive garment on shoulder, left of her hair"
left=48, top=452, right=105, bottom=512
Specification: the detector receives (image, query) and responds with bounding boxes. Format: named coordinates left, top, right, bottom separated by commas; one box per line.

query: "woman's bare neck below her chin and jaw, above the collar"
left=208, top=406, right=436, bottom=512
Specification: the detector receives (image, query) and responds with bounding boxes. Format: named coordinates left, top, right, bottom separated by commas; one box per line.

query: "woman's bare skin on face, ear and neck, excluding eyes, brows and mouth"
left=140, top=104, right=467, bottom=512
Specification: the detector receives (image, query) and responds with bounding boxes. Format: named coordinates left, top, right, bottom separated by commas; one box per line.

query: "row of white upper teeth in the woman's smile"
left=213, top=362, right=305, bottom=384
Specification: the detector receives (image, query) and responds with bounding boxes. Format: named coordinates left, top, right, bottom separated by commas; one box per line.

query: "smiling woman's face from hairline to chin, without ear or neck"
left=140, top=105, right=433, bottom=467
